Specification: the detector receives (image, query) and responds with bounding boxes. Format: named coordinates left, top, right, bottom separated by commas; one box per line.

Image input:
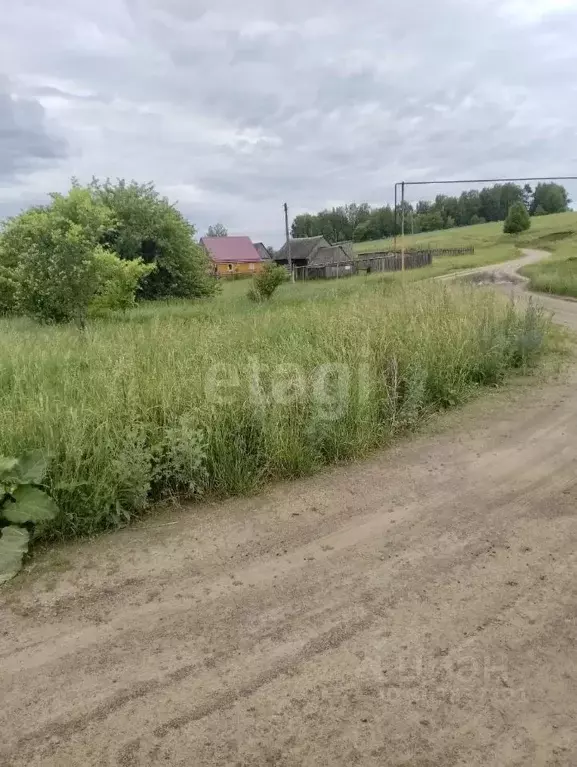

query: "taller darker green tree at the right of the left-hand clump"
left=90, top=179, right=216, bottom=299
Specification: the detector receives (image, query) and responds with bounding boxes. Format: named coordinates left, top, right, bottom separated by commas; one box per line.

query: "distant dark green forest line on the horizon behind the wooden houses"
left=291, top=183, right=571, bottom=242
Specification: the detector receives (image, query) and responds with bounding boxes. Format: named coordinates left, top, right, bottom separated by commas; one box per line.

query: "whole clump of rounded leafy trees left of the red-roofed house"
left=0, top=180, right=214, bottom=325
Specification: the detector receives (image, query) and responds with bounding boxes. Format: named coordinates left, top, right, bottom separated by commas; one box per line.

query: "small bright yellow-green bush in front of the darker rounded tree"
left=90, top=248, right=156, bottom=311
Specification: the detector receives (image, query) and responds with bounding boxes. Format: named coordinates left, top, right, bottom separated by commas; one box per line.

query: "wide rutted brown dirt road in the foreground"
left=0, top=250, right=577, bottom=767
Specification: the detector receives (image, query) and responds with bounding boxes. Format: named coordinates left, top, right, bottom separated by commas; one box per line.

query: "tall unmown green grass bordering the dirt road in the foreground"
left=0, top=276, right=548, bottom=538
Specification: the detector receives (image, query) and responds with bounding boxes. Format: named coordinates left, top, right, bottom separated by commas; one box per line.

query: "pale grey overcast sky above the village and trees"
left=0, top=0, right=577, bottom=244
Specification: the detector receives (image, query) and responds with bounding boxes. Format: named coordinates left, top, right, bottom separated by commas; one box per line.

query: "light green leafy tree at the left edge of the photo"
left=1, top=190, right=113, bottom=325
